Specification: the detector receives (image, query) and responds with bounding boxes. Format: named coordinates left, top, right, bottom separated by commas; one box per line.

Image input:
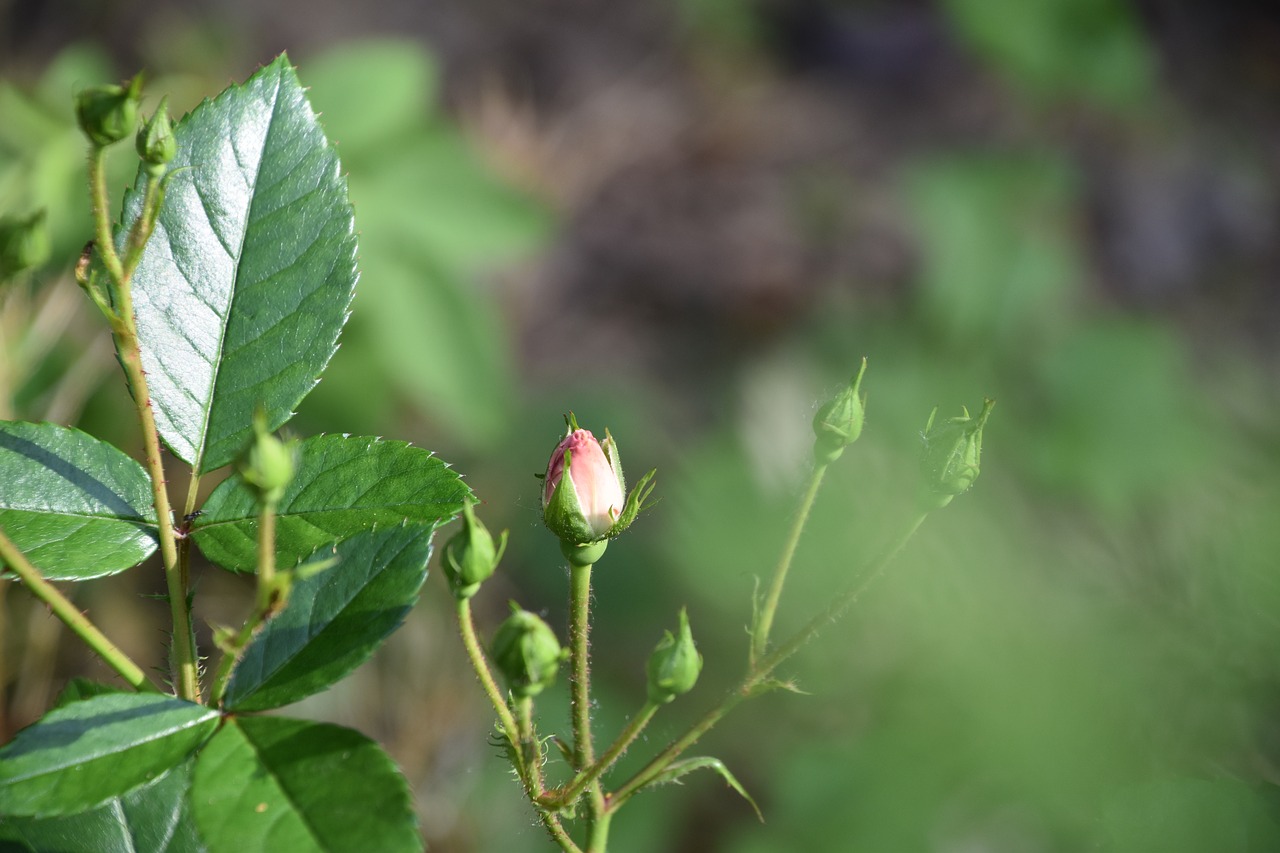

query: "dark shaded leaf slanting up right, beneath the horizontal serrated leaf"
left=223, top=525, right=431, bottom=712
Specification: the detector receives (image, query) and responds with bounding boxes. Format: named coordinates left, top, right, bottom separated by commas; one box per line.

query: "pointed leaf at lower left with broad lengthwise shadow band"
left=0, top=693, right=218, bottom=817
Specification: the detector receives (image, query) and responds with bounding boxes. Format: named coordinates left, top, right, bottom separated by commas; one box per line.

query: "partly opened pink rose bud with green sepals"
left=543, top=414, right=655, bottom=549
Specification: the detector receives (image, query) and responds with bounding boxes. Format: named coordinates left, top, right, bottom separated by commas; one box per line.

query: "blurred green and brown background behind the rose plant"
left=0, top=0, right=1280, bottom=853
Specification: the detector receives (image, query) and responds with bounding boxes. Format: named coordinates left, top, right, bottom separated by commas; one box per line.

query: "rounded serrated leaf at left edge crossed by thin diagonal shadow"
left=0, top=421, right=156, bottom=580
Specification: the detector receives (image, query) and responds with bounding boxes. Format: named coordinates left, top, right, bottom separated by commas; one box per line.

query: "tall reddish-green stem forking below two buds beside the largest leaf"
left=88, top=146, right=200, bottom=702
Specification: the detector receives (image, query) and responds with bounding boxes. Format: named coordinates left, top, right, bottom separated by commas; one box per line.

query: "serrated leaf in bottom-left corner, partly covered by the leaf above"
left=0, top=760, right=204, bottom=853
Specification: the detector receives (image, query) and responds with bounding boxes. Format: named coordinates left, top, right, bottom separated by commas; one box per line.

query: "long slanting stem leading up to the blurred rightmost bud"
left=608, top=512, right=927, bottom=812
